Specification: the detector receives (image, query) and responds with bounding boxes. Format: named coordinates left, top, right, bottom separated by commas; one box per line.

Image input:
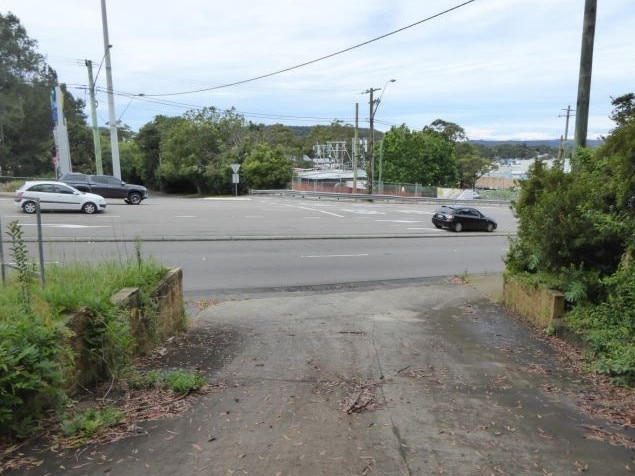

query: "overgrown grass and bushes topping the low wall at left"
left=0, top=260, right=167, bottom=438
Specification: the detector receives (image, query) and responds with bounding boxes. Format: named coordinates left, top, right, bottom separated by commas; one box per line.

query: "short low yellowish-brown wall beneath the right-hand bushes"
left=503, top=274, right=565, bottom=329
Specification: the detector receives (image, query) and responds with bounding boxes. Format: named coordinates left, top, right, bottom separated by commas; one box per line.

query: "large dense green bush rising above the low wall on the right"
left=507, top=93, right=635, bottom=301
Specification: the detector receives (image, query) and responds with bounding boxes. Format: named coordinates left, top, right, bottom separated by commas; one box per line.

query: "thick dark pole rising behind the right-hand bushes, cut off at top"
left=574, top=0, right=597, bottom=154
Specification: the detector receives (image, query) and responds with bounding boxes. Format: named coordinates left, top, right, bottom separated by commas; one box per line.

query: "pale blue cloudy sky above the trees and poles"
left=0, top=0, right=635, bottom=140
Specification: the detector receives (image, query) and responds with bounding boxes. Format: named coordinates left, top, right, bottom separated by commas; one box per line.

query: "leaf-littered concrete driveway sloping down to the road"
left=14, top=280, right=635, bottom=476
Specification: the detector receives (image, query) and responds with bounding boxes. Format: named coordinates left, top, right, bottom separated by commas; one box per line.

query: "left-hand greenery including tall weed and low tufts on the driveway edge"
left=0, top=222, right=204, bottom=441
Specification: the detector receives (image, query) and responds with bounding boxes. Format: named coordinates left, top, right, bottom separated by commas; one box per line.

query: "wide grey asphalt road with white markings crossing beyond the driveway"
left=0, top=196, right=516, bottom=295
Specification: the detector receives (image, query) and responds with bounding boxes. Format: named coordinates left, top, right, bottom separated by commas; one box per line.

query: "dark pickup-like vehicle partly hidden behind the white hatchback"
left=59, top=172, right=148, bottom=205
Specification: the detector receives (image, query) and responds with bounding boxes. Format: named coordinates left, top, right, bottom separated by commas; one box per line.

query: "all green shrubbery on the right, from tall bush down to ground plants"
left=506, top=93, right=635, bottom=386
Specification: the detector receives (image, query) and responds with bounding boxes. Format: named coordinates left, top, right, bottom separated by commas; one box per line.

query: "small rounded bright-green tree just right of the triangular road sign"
left=242, top=144, right=293, bottom=189
